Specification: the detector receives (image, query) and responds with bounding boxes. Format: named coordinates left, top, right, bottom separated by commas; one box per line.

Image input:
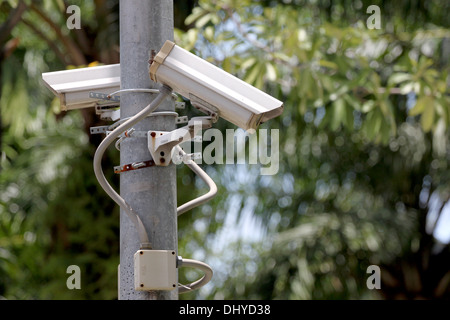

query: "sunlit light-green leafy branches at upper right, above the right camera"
left=178, top=1, right=450, bottom=144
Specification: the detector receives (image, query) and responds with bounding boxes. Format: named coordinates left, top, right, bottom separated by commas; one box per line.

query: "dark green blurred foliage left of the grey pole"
left=0, top=1, right=119, bottom=299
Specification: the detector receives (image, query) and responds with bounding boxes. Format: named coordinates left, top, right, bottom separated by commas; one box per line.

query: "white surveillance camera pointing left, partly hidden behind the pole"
left=42, top=64, right=120, bottom=111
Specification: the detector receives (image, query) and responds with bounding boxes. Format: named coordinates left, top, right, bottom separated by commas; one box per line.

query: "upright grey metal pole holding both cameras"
left=119, top=0, right=178, bottom=300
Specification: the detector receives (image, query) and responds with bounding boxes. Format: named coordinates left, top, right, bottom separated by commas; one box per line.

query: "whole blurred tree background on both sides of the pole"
left=0, top=0, right=450, bottom=299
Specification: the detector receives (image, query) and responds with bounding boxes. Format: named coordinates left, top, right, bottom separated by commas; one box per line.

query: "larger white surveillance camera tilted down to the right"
left=149, top=40, right=283, bottom=130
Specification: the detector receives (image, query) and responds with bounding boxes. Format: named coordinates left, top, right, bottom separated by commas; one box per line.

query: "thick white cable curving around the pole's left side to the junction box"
left=94, top=86, right=172, bottom=246
